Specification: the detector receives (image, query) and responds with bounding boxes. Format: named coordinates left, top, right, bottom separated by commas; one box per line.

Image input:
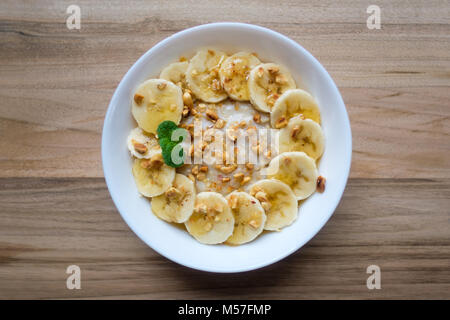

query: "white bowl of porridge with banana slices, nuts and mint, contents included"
left=102, top=23, right=351, bottom=272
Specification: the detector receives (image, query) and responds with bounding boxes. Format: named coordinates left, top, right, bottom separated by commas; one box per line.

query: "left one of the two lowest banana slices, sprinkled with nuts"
left=185, top=192, right=234, bottom=244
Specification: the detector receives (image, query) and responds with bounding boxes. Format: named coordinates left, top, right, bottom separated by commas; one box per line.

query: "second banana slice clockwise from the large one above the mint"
left=186, top=49, right=227, bottom=103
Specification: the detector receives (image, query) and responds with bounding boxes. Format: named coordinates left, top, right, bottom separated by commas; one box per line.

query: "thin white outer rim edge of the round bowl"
left=101, top=22, right=352, bottom=273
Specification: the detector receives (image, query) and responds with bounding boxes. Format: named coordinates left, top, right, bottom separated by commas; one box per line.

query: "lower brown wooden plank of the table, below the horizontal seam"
left=0, top=178, right=450, bottom=299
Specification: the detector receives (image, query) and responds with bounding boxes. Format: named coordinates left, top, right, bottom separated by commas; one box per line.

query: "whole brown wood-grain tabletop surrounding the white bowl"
left=0, top=0, right=450, bottom=299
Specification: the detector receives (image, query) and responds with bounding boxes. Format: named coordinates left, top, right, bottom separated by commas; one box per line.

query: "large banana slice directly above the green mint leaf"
left=131, top=79, right=183, bottom=133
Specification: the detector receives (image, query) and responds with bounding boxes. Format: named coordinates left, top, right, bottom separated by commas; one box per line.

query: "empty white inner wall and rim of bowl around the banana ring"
left=102, top=23, right=352, bottom=272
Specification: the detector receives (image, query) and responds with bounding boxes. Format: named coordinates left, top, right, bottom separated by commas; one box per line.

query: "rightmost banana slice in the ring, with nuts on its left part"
left=279, top=116, right=325, bottom=160
